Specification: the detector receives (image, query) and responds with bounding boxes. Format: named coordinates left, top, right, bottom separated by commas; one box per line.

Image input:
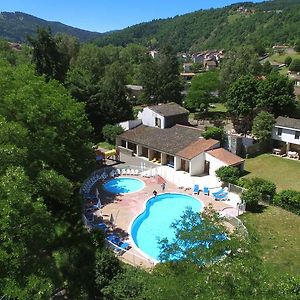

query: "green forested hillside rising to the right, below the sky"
left=95, top=0, right=300, bottom=51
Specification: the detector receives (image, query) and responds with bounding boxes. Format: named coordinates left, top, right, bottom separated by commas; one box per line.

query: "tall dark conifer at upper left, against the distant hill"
left=28, top=28, right=68, bottom=82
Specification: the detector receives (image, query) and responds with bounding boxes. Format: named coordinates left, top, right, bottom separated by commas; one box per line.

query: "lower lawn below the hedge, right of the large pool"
left=241, top=205, right=300, bottom=276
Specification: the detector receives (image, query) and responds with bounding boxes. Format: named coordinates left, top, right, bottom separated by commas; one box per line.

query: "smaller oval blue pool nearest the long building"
left=103, top=177, right=145, bottom=194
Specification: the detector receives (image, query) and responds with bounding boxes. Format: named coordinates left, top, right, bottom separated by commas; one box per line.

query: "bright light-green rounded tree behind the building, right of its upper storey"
left=184, top=71, right=219, bottom=112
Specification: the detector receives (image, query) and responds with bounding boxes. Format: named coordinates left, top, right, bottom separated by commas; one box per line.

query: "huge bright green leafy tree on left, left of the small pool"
left=0, top=62, right=93, bottom=180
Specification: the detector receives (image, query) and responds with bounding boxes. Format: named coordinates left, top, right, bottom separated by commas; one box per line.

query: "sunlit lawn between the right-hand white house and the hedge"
left=245, top=154, right=300, bottom=191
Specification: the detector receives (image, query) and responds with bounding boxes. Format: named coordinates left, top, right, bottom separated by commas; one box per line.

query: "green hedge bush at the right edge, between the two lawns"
left=274, top=190, right=300, bottom=215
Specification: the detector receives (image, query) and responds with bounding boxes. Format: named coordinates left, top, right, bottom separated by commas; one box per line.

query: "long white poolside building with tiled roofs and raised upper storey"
left=116, top=103, right=244, bottom=176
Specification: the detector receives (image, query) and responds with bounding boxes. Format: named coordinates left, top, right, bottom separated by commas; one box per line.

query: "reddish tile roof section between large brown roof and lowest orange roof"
left=176, top=138, right=219, bottom=159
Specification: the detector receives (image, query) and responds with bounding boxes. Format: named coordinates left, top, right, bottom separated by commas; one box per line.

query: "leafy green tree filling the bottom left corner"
left=0, top=167, right=57, bottom=299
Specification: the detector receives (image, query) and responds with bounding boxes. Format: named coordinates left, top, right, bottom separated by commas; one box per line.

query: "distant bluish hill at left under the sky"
left=0, top=12, right=101, bottom=42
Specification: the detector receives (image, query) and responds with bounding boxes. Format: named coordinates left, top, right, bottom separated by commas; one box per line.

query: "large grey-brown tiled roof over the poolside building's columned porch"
left=119, top=125, right=201, bottom=155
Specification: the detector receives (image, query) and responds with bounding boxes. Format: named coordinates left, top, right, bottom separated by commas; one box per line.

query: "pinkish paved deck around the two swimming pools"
left=94, top=176, right=230, bottom=268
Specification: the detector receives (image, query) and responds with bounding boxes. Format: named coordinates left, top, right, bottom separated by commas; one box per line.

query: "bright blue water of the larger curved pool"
left=131, top=193, right=203, bottom=260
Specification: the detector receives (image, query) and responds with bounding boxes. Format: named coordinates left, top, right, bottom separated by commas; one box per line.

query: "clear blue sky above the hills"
left=0, top=0, right=261, bottom=32
